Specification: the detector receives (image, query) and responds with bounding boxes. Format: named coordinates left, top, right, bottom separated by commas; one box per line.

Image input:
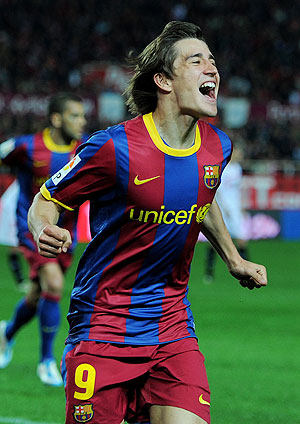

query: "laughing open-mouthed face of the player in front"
left=171, top=38, right=220, bottom=118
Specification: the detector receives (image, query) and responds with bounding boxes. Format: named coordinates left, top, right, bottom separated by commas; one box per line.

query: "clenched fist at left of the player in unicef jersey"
left=36, top=224, right=72, bottom=258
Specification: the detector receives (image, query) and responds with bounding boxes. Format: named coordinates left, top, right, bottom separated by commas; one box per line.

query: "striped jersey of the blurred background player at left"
left=0, top=128, right=88, bottom=250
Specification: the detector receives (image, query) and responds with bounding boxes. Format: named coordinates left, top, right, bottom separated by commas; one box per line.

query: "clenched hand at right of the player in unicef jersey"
left=229, top=259, right=268, bottom=290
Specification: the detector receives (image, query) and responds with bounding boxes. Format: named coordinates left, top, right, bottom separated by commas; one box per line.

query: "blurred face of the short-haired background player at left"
left=61, top=100, right=86, bottom=140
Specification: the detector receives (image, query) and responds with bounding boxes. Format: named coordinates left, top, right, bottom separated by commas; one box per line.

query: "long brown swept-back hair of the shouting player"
left=123, top=21, right=205, bottom=115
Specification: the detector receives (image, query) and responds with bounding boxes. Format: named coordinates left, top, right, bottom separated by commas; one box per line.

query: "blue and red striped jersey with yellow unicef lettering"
left=41, top=113, right=232, bottom=345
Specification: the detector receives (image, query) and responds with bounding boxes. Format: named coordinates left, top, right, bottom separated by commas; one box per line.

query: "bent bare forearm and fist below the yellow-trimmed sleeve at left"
left=28, top=193, right=72, bottom=258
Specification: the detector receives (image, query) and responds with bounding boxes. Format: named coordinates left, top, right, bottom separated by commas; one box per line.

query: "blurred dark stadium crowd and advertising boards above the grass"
left=0, top=0, right=300, bottom=239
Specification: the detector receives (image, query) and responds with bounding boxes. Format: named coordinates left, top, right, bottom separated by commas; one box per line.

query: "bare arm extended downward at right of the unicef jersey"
left=202, top=200, right=267, bottom=289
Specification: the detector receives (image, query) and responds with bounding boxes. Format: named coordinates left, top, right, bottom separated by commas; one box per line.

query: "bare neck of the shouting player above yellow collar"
left=153, top=108, right=197, bottom=149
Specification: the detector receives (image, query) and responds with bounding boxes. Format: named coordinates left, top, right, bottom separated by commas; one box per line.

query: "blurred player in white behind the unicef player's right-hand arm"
left=203, top=144, right=248, bottom=284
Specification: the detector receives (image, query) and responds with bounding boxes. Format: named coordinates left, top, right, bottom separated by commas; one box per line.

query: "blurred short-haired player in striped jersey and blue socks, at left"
left=0, top=93, right=87, bottom=386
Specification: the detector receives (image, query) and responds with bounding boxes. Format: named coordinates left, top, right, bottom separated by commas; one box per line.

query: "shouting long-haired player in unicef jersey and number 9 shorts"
left=28, top=21, right=267, bottom=424
